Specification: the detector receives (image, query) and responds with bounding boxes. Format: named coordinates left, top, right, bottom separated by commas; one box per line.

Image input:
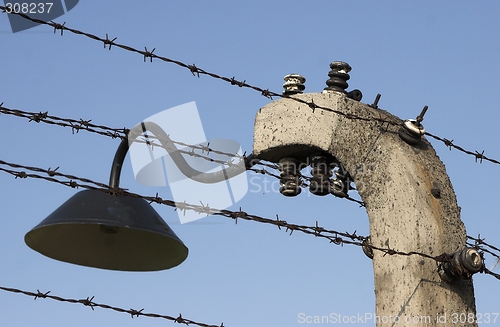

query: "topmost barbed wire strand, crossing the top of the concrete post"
left=0, top=6, right=500, bottom=164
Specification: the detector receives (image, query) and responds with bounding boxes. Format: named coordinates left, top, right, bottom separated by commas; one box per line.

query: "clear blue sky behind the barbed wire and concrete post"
left=0, top=1, right=500, bottom=326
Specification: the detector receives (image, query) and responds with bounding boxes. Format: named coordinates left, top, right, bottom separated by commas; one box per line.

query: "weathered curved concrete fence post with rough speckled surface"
left=254, top=93, right=476, bottom=326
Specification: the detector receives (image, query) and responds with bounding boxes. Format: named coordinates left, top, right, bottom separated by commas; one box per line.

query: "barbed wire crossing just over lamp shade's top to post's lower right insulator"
left=0, top=160, right=500, bottom=280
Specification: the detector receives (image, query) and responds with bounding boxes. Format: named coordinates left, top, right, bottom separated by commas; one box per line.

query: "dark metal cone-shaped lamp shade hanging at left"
left=24, top=190, right=188, bottom=271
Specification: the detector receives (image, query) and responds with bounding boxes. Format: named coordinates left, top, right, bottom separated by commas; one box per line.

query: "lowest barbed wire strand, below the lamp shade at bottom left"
left=0, top=286, right=224, bottom=327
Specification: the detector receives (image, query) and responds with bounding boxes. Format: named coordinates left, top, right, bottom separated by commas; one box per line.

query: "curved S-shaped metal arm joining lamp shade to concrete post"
left=109, top=122, right=256, bottom=188
